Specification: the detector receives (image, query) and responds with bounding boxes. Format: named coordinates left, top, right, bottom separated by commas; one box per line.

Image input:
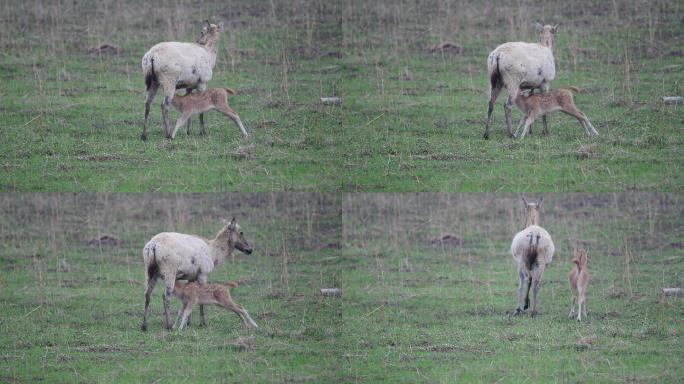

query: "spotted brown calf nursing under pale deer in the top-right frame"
left=514, top=87, right=598, bottom=138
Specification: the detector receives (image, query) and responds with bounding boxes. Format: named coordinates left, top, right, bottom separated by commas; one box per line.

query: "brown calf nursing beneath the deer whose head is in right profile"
left=173, top=280, right=259, bottom=330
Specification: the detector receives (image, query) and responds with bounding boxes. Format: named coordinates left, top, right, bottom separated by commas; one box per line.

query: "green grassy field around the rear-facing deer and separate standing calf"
left=339, top=194, right=684, bottom=383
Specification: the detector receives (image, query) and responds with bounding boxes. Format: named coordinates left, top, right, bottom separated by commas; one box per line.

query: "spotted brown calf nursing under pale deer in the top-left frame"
left=171, top=88, right=249, bottom=139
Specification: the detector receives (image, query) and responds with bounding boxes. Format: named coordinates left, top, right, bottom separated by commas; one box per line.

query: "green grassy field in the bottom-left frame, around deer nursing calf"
left=0, top=194, right=342, bottom=383
